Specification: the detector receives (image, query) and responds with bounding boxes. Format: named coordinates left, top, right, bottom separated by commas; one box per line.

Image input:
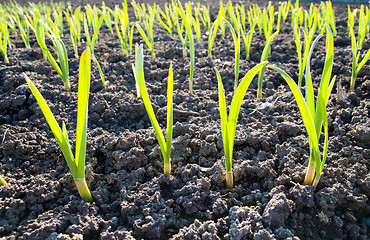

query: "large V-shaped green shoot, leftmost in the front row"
left=25, top=49, right=93, bottom=202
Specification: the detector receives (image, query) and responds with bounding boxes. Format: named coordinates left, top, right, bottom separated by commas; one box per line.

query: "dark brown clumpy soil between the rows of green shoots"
left=0, top=0, right=370, bottom=240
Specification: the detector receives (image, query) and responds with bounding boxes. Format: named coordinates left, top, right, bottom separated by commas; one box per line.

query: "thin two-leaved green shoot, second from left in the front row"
left=134, top=44, right=173, bottom=174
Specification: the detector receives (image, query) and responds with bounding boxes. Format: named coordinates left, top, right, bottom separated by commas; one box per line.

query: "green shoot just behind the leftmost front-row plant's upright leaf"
left=35, top=19, right=71, bottom=91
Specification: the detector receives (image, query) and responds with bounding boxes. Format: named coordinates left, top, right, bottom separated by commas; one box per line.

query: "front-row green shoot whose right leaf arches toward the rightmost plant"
left=215, top=62, right=267, bottom=188
